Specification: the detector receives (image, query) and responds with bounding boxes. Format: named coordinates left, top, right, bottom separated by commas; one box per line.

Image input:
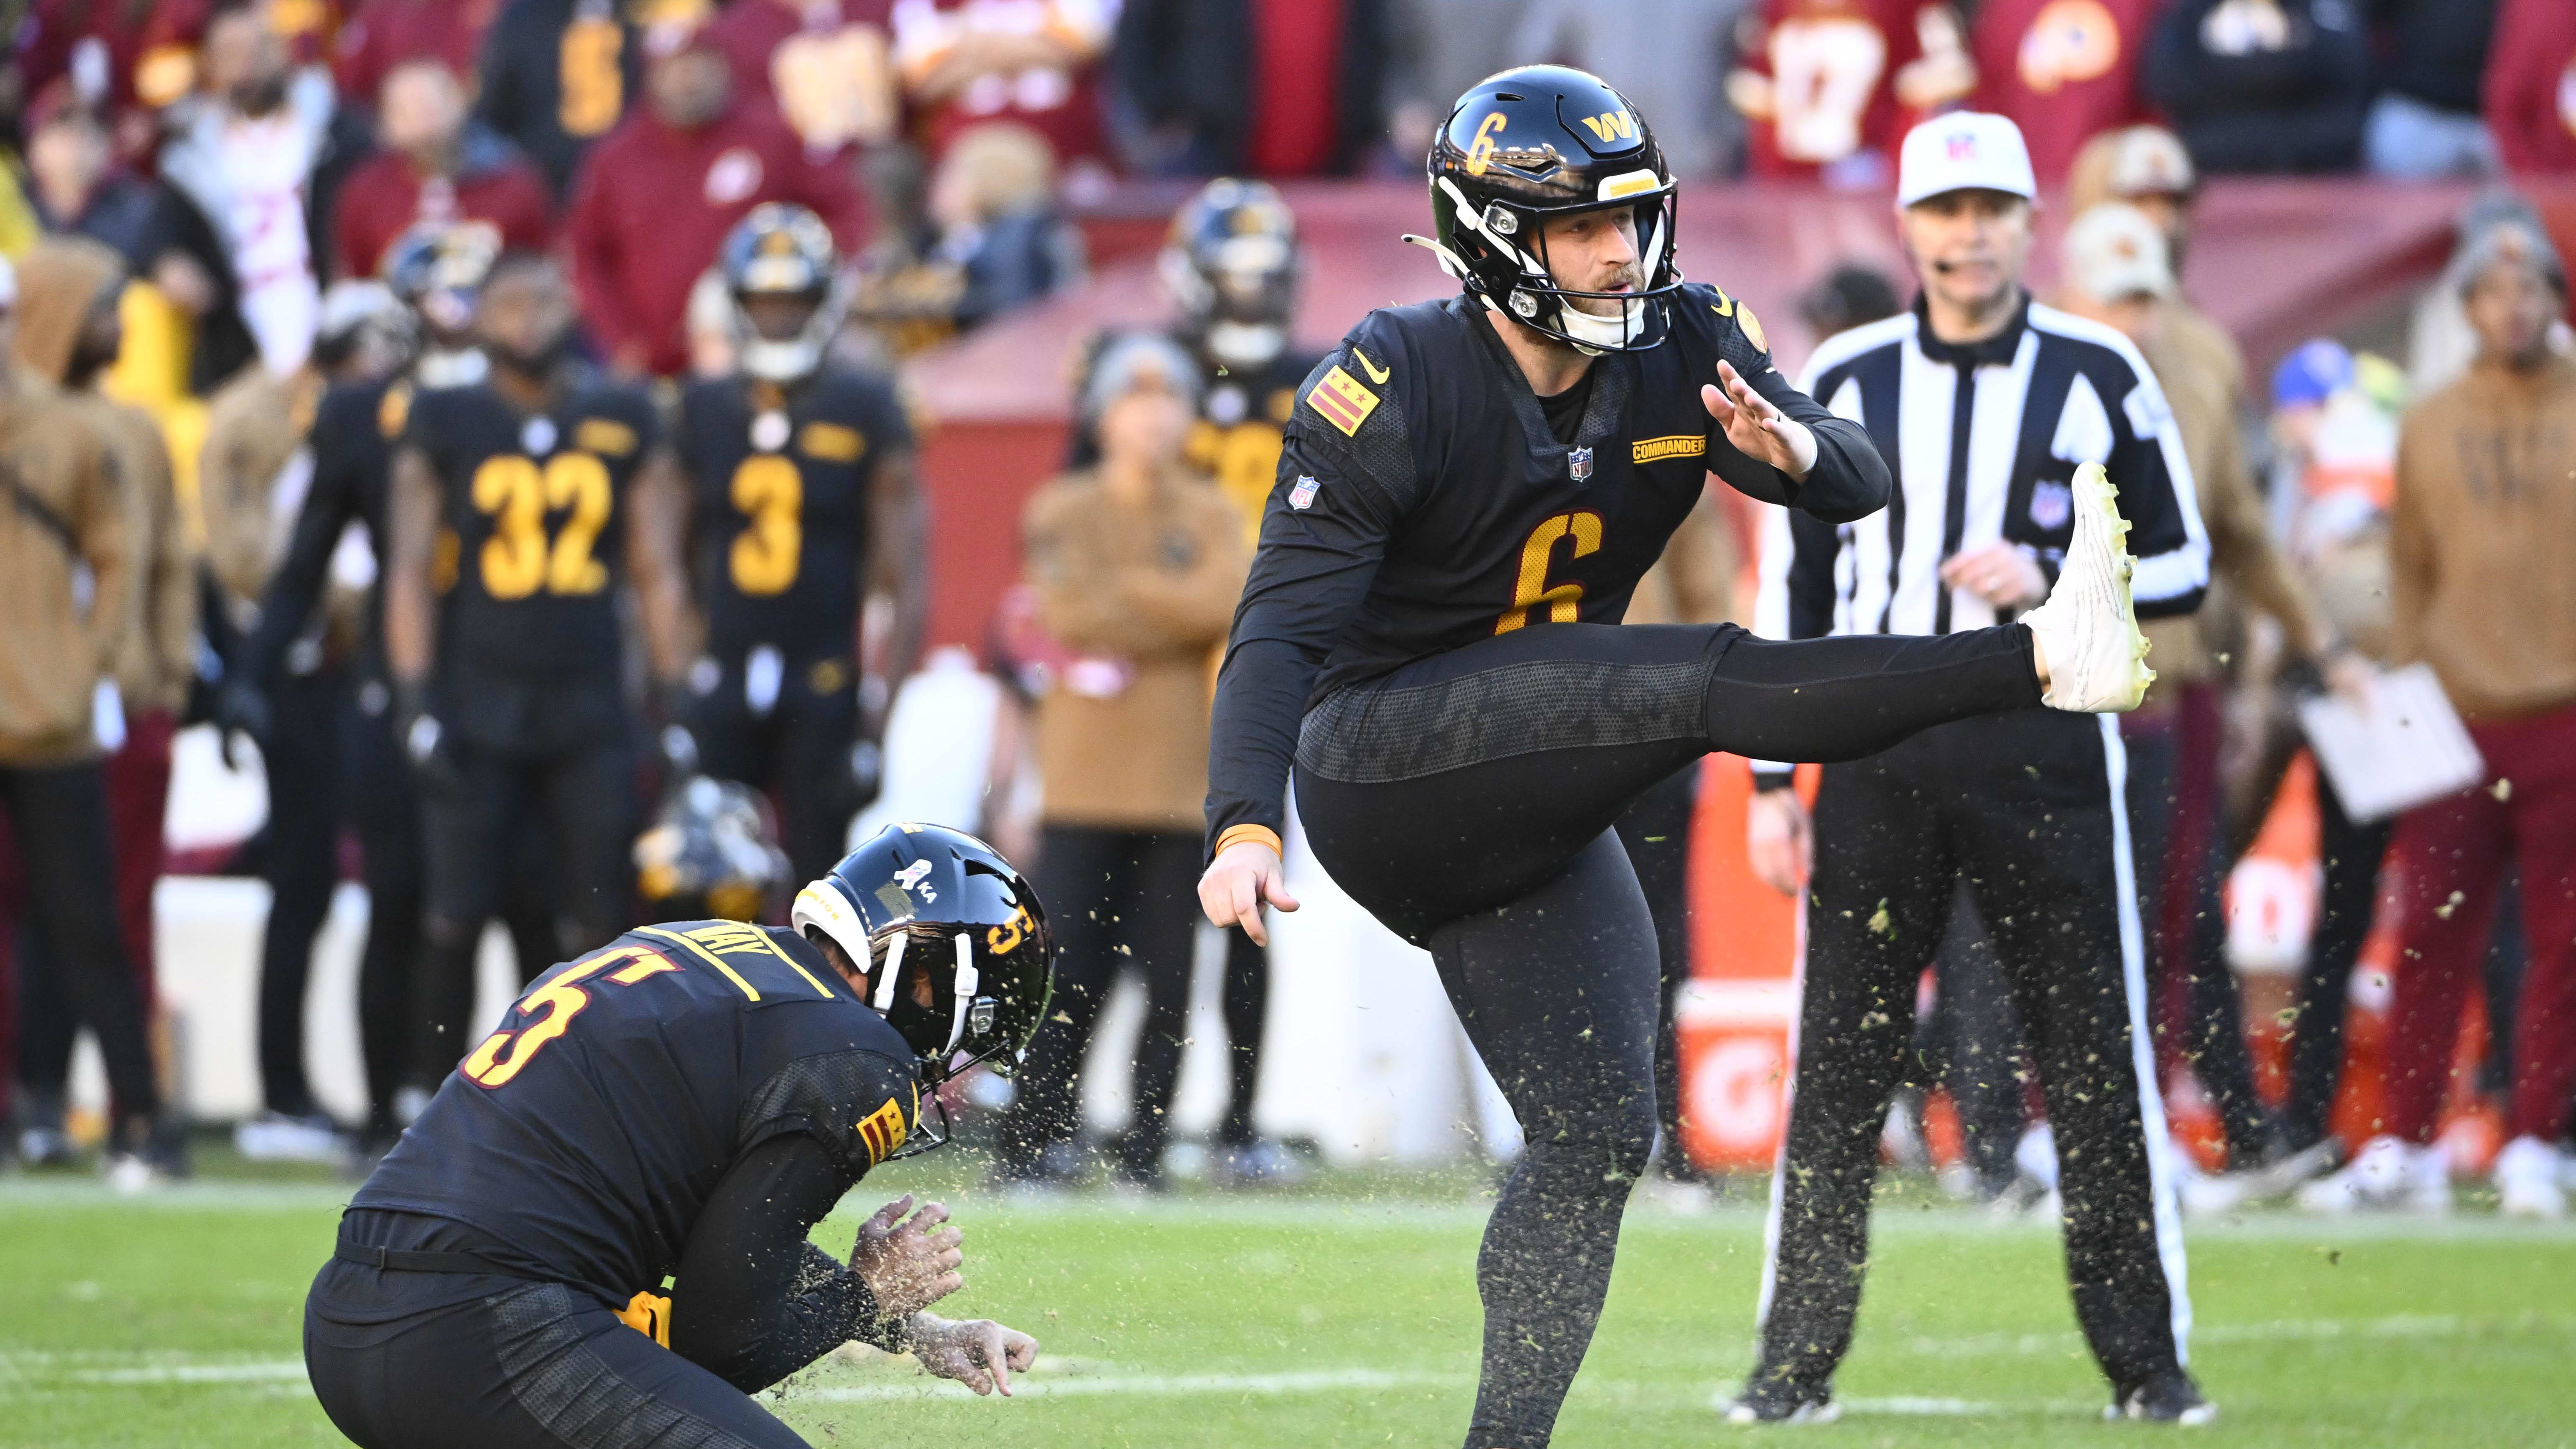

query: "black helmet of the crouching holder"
left=788, top=825, right=1056, bottom=1085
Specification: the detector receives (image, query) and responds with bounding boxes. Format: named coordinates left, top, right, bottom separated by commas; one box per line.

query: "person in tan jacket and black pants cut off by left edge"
left=0, top=254, right=186, bottom=1186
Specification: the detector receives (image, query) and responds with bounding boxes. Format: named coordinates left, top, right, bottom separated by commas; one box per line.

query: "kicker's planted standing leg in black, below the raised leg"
left=1432, top=833, right=1656, bottom=1449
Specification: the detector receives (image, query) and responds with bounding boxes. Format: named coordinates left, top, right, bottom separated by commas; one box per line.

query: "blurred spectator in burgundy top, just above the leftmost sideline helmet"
left=332, top=57, right=554, bottom=276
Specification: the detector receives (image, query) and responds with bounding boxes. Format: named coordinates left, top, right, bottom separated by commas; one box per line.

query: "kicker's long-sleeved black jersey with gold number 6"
left=1208, top=283, right=1888, bottom=841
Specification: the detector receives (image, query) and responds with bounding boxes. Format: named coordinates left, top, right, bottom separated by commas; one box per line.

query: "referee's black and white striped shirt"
left=1754, top=302, right=2210, bottom=650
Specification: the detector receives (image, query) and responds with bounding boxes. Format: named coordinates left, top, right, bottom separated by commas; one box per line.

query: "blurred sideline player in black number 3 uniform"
left=654, top=204, right=930, bottom=877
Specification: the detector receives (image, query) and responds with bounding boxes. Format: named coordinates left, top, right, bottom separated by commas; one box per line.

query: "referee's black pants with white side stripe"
left=1757, top=709, right=2190, bottom=1395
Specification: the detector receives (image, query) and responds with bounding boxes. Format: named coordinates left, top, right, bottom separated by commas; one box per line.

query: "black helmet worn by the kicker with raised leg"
left=1404, top=64, right=1682, bottom=353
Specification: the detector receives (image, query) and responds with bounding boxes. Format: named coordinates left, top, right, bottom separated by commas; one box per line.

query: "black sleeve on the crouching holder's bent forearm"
left=670, top=1132, right=891, bottom=1392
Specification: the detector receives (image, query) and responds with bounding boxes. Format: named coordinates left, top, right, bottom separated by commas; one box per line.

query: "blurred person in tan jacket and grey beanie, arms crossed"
left=1002, top=333, right=1250, bottom=1186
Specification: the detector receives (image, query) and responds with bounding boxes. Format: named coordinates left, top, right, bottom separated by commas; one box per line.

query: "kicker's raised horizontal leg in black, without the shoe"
left=1296, top=624, right=2040, bottom=944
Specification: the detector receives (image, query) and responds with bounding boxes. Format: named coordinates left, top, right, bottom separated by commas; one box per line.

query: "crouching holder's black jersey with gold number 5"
left=350, top=921, right=920, bottom=1305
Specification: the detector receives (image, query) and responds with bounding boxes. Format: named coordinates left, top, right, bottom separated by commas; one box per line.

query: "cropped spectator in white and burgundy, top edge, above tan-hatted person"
left=894, top=0, right=1115, bottom=175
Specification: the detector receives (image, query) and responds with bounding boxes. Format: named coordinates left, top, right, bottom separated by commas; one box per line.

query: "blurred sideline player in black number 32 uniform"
left=384, top=253, right=688, bottom=1116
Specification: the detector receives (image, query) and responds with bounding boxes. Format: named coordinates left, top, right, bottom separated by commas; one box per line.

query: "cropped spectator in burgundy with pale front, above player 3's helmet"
left=706, top=0, right=899, bottom=155
